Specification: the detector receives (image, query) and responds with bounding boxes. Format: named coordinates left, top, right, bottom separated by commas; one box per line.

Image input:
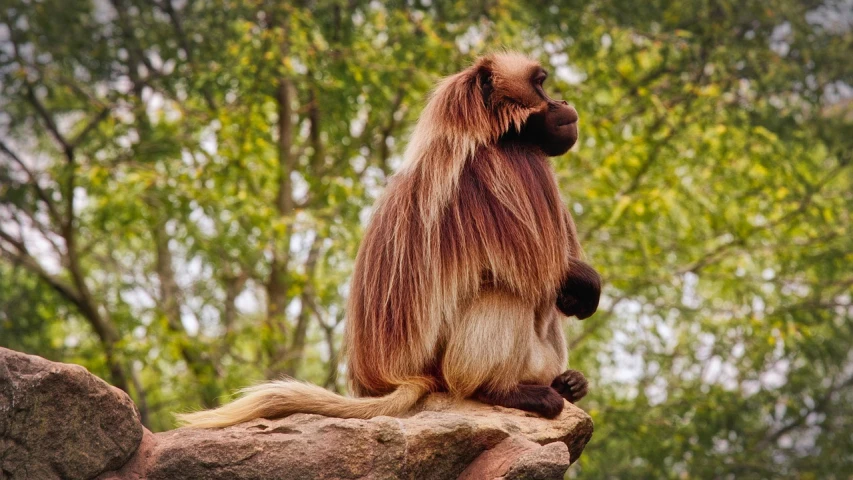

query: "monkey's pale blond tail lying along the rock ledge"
left=177, top=380, right=428, bottom=428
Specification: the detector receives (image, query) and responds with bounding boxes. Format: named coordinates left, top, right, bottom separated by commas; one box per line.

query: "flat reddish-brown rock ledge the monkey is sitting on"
left=143, top=395, right=592, bottom=480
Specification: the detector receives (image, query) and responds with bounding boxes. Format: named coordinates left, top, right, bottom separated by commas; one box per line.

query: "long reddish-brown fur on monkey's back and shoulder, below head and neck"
left=346, top=144, right=569, bottom=395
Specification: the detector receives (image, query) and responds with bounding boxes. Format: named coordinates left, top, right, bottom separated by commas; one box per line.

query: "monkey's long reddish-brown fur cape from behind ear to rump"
left=346, top=53, right=573, bottom=395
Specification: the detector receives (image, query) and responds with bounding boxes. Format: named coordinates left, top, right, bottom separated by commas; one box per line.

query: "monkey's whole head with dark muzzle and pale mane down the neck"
left=404, top=53, right=578, bottom=169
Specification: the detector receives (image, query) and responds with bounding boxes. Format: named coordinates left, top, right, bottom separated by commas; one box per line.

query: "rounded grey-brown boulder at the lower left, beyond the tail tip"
left=0, top=348, right=142, bottom=480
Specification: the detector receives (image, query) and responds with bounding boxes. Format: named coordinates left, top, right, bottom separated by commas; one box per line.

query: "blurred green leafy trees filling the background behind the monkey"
left=0, top=0, right=853, bottom=478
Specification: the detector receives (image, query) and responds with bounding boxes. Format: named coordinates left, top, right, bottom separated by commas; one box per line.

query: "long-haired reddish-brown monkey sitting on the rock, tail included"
left=179, top=52, right=601, bottom=428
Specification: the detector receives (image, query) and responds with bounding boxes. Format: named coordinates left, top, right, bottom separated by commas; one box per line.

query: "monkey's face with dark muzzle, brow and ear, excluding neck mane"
left=473, top=53, right=578, bottom=156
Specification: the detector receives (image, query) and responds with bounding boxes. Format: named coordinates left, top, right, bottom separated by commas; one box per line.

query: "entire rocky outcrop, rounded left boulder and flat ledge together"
left=0, top=349, right=592, bottom=480
